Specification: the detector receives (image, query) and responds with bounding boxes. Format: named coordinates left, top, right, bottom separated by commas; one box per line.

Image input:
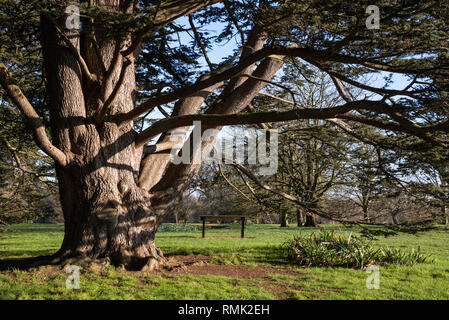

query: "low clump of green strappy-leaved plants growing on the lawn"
left=284, top=231, right=431, bottom=269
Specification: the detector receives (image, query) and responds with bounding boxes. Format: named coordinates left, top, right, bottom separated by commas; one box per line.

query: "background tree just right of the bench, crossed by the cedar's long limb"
left=228, top=69, right=354, bottom=227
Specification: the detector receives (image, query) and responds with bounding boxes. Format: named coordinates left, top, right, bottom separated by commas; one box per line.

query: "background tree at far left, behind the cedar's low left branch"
left=0, top=97, right=57, bottom=225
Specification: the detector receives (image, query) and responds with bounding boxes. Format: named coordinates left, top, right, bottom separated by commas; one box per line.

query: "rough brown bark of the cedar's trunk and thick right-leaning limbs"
left=0, top=0, right=282, bottom=270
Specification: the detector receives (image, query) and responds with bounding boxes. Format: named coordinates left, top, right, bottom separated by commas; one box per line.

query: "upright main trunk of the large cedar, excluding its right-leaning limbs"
left=42, top=5, right=163, bottom=269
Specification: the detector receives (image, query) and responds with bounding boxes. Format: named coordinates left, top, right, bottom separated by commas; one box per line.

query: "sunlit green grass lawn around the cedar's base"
left=0, top=224, right=449, bottom=300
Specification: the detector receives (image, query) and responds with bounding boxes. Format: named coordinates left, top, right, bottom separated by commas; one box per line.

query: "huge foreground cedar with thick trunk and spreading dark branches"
left=0, top=0, right=449, bottom=269
